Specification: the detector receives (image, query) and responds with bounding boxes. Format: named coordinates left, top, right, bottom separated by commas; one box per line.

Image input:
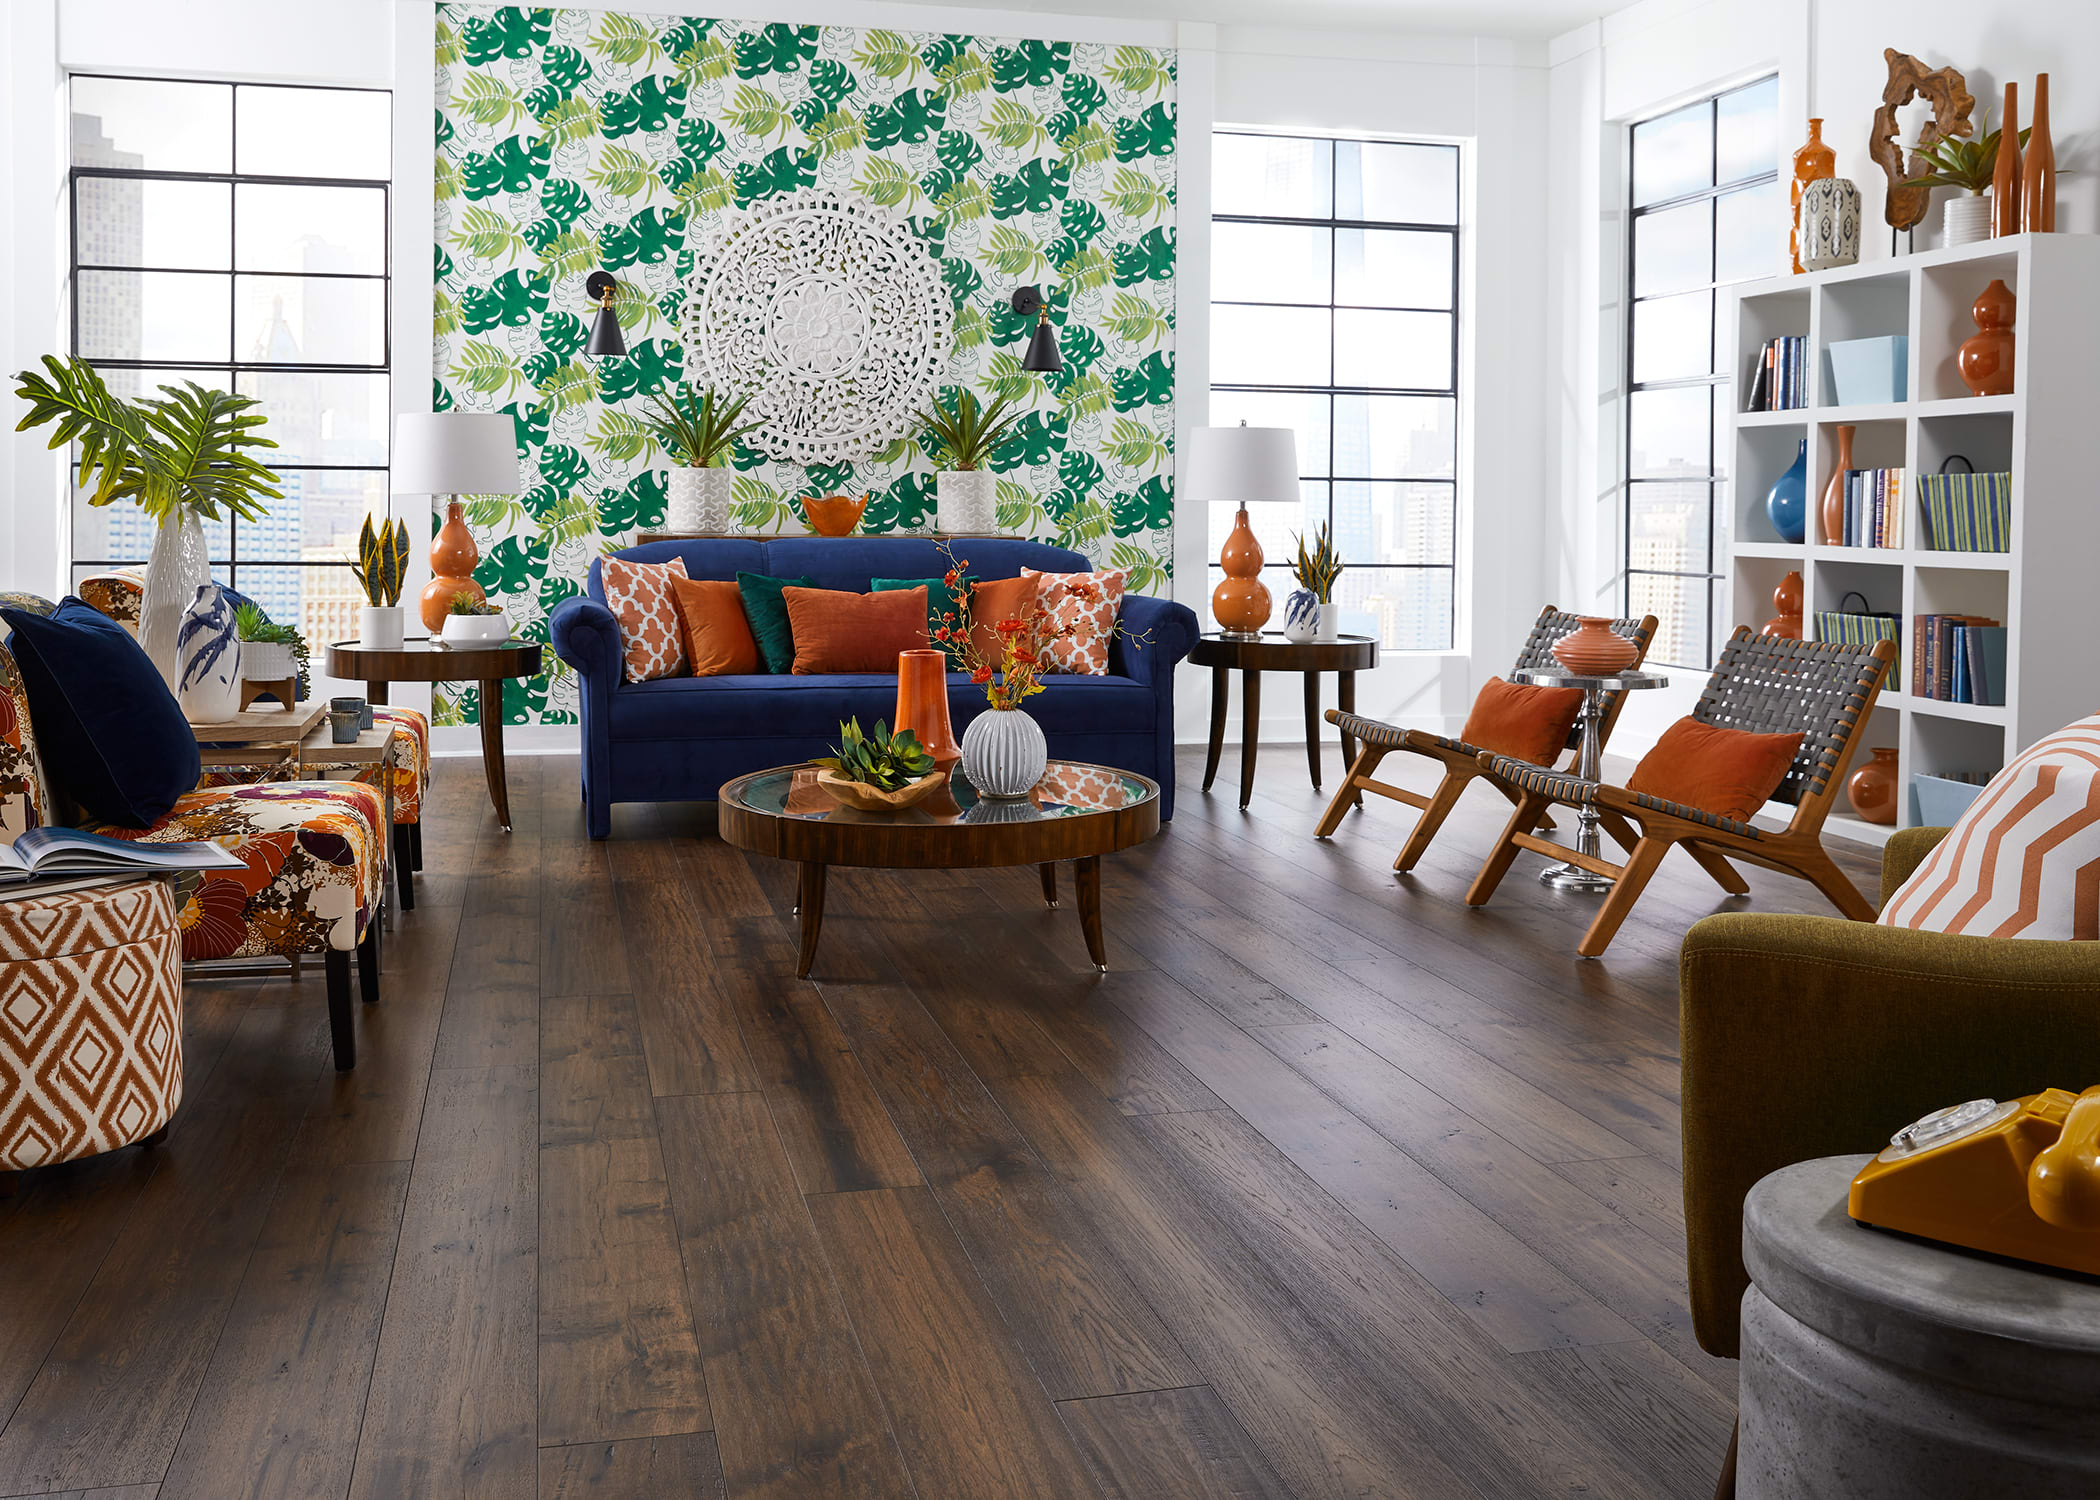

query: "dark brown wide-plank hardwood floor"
left=0, top=748, right=1875, bottom=1500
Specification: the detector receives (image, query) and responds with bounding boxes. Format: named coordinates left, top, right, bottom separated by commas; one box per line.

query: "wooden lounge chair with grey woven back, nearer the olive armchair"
left=1466, top=626, right=1896, bottom=958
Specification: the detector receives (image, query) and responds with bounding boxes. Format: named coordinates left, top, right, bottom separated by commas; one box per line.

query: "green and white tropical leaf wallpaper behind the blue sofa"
left=433, top=4, right=1176, bottom=723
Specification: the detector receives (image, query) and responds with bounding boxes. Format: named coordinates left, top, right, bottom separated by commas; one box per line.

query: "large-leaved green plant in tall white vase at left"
left=15, top=355, right=284, bottom=693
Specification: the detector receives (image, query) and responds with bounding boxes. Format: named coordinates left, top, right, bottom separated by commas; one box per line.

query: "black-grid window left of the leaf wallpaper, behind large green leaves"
left=71, top=76, right=393, bottom=647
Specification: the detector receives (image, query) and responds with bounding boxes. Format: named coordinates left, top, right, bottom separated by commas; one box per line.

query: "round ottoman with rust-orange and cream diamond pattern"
left=0, top=880, right=183, bottom=1168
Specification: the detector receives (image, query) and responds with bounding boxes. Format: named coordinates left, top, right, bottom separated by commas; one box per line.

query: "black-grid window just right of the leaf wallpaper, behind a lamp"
left=1210, top=130, right=1460, bottom=651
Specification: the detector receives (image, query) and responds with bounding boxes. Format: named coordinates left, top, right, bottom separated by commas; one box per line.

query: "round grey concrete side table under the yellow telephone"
left=1737, top=1155, right=2100, bottom=1500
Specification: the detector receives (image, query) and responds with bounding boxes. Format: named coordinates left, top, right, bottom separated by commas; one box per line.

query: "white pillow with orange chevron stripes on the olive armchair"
left=1882, top=714, right=2100, bottom=941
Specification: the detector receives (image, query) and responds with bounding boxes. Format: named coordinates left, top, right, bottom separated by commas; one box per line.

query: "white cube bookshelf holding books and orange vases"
left=1720, top=235, right=2100, bottom=842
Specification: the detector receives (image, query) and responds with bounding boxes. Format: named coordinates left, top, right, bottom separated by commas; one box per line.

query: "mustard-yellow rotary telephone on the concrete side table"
left=1848, top=1086, right=2100, bottom=1275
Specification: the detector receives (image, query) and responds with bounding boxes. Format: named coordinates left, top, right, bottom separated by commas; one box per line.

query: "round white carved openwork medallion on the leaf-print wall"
left=685, top=189, right=956, bottom=464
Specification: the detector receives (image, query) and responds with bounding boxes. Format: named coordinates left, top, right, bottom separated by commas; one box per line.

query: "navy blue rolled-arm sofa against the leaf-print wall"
left=548, top=536, right=1197, bottom=838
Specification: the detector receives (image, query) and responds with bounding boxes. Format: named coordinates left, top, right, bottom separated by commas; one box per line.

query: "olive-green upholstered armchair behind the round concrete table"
left=1680, top=911, right=2100, bottom=1357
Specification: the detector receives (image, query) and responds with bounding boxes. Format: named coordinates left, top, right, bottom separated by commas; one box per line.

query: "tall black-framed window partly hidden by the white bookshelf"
left=1623, top=78, right=1779, bottom=668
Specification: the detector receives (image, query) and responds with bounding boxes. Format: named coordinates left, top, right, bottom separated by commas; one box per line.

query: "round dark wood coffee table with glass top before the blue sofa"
left=720, top=761, right=1159, bottom=979
